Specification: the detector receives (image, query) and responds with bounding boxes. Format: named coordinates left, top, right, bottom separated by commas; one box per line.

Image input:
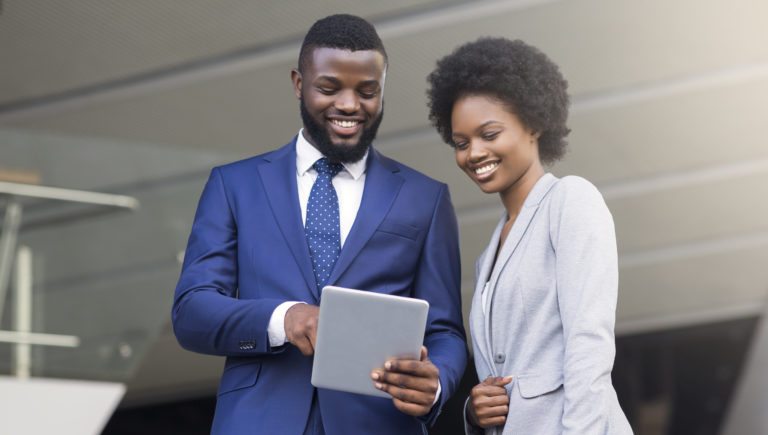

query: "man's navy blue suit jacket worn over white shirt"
left=172, top=139, right=467, bottom=435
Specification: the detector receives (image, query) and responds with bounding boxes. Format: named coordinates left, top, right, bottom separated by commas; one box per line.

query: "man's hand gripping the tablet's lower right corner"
left=371, top=346, right=440, bottom=417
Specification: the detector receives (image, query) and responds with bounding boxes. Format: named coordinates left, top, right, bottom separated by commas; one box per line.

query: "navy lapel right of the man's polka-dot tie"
left=328, top=147, right=403, bottom=284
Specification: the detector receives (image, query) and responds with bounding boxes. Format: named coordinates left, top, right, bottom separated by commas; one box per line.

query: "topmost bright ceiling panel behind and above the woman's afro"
left=382, top=0, right=768, bottom=132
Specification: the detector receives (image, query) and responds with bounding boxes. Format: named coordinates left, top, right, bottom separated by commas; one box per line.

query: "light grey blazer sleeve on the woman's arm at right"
left=550, top=177, right=618, bottom=434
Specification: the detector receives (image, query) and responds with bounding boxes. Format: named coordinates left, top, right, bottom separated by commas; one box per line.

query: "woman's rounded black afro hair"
left=427, top=38, right=570, bottom=164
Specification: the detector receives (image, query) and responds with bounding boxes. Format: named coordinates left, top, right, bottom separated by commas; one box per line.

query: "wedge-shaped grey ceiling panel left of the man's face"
left=5, top=63, right=301, bottom=156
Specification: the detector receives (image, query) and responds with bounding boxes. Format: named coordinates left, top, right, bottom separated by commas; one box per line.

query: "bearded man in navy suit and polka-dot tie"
left=172, top=15, right=466, bottom=435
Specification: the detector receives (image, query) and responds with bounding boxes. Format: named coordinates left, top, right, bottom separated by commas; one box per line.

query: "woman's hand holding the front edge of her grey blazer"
left=467, top=376, right=512, bottom=429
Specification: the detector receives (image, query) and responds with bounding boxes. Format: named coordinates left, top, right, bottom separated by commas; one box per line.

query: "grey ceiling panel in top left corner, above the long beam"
left=0, top=0, right=456, bottom=103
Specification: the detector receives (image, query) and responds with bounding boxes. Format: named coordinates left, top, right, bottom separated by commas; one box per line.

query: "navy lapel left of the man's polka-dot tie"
left=258, top=138, right=317, bottom=296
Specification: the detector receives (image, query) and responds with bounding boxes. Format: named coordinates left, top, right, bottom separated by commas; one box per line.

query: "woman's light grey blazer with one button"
left=466, top=174, right=632, bottom=435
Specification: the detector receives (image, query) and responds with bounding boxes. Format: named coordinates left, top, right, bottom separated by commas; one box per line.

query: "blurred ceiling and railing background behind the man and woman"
left=0, top=0, right=768, bottom=435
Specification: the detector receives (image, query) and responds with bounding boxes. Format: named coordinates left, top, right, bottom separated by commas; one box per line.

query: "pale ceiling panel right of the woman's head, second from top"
left=558, top=76, right=768, bottom=183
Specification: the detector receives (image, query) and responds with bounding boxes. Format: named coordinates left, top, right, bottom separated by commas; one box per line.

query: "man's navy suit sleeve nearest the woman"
left=414, top=185, right=467, bottom=425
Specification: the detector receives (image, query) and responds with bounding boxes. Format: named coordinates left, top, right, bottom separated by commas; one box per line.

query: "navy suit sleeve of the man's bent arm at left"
left=171, top=168, right=285, bottom=356
